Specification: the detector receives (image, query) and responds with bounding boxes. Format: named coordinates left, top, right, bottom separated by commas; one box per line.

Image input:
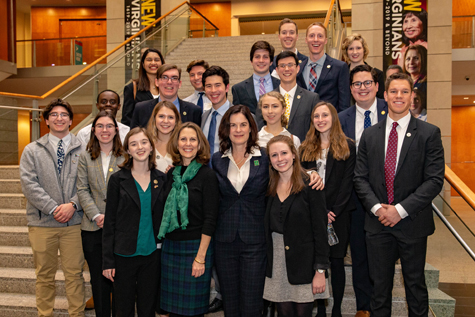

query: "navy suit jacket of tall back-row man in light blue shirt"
left=297, top=55, right=351, bottom=112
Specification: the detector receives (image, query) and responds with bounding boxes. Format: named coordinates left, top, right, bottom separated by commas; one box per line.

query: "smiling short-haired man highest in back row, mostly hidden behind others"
left=269, top=18, right=308, bottom=77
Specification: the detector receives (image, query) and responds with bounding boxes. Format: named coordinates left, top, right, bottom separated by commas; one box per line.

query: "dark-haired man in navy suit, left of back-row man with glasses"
left=231, top=41, right=280, bottom=114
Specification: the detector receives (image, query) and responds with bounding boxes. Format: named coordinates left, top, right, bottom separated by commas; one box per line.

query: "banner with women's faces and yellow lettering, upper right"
left=383, top=0, right=428, bottom=121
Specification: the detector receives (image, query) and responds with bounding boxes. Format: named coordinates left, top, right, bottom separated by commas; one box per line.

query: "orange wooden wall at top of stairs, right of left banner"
left=190, top=2, right=231, bottom=37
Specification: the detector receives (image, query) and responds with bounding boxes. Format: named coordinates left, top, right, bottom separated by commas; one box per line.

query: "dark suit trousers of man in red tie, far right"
left=366, top=228, right=429, bottom=317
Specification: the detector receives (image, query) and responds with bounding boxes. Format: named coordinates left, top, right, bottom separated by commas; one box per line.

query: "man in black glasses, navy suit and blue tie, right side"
left=338, top=65, right=388, bottom=317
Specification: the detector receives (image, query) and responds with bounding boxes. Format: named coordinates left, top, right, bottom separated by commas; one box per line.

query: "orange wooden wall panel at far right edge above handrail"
left=451, top=106, right=475, bottom=195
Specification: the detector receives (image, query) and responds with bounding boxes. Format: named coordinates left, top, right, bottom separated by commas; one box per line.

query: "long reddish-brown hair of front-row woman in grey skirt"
left=267, top=135, right=308, bottom=196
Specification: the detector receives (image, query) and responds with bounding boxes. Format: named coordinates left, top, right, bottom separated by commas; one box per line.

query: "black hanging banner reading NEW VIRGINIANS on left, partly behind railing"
left=124, top=0, right=161, bottom=82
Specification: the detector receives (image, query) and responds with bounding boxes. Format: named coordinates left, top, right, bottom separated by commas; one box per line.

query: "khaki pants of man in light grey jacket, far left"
left=28, top=225, right=86, bottom=316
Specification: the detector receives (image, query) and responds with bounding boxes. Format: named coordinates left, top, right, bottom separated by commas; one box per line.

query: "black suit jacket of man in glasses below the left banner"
left=130, top=98, right=201, bottom=129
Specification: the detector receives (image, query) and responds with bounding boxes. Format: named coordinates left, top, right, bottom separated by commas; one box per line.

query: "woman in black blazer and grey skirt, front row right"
left=264, top=135, right=330, bottom=317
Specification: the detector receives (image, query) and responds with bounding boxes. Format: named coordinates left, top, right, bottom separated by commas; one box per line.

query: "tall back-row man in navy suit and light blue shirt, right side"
left=300, top=22, right=350, bottom=112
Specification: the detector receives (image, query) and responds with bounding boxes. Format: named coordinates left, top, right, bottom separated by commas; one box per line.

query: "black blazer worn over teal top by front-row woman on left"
left=102, top=169, right=166, bottom=270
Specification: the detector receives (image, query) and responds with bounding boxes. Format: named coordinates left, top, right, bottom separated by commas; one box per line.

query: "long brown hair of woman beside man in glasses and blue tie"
left=300, top=101, right=350, bottom=162
